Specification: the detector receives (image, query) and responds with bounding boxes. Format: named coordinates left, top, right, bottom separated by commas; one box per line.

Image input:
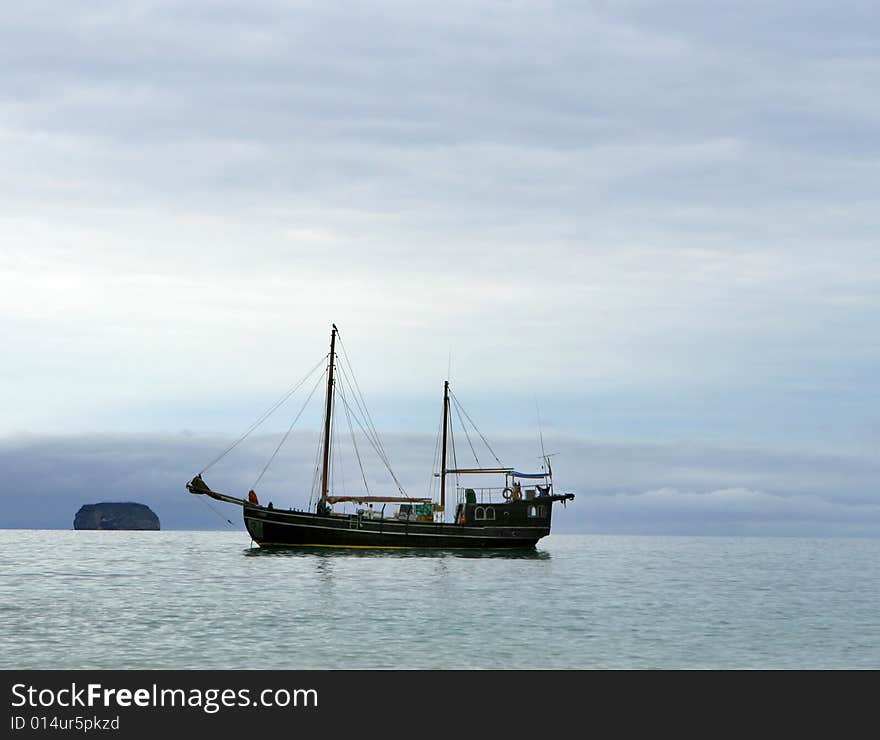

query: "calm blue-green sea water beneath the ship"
left=0, top=530, right=880, bottom=669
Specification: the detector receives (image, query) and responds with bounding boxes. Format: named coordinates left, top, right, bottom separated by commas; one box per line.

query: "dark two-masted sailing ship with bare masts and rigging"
left=186, top=324, right=574, bottom=549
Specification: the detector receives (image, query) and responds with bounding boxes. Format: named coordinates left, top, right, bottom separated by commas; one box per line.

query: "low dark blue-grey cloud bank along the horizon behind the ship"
left=0, top=431, right=880, bottom=537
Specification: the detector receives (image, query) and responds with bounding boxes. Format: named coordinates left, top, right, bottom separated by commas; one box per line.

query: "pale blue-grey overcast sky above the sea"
left=0, top=0, right=880, bottom=536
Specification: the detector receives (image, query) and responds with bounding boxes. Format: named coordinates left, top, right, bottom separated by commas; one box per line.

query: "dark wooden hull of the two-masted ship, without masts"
left=244, top=494, right=573, bottom=549
